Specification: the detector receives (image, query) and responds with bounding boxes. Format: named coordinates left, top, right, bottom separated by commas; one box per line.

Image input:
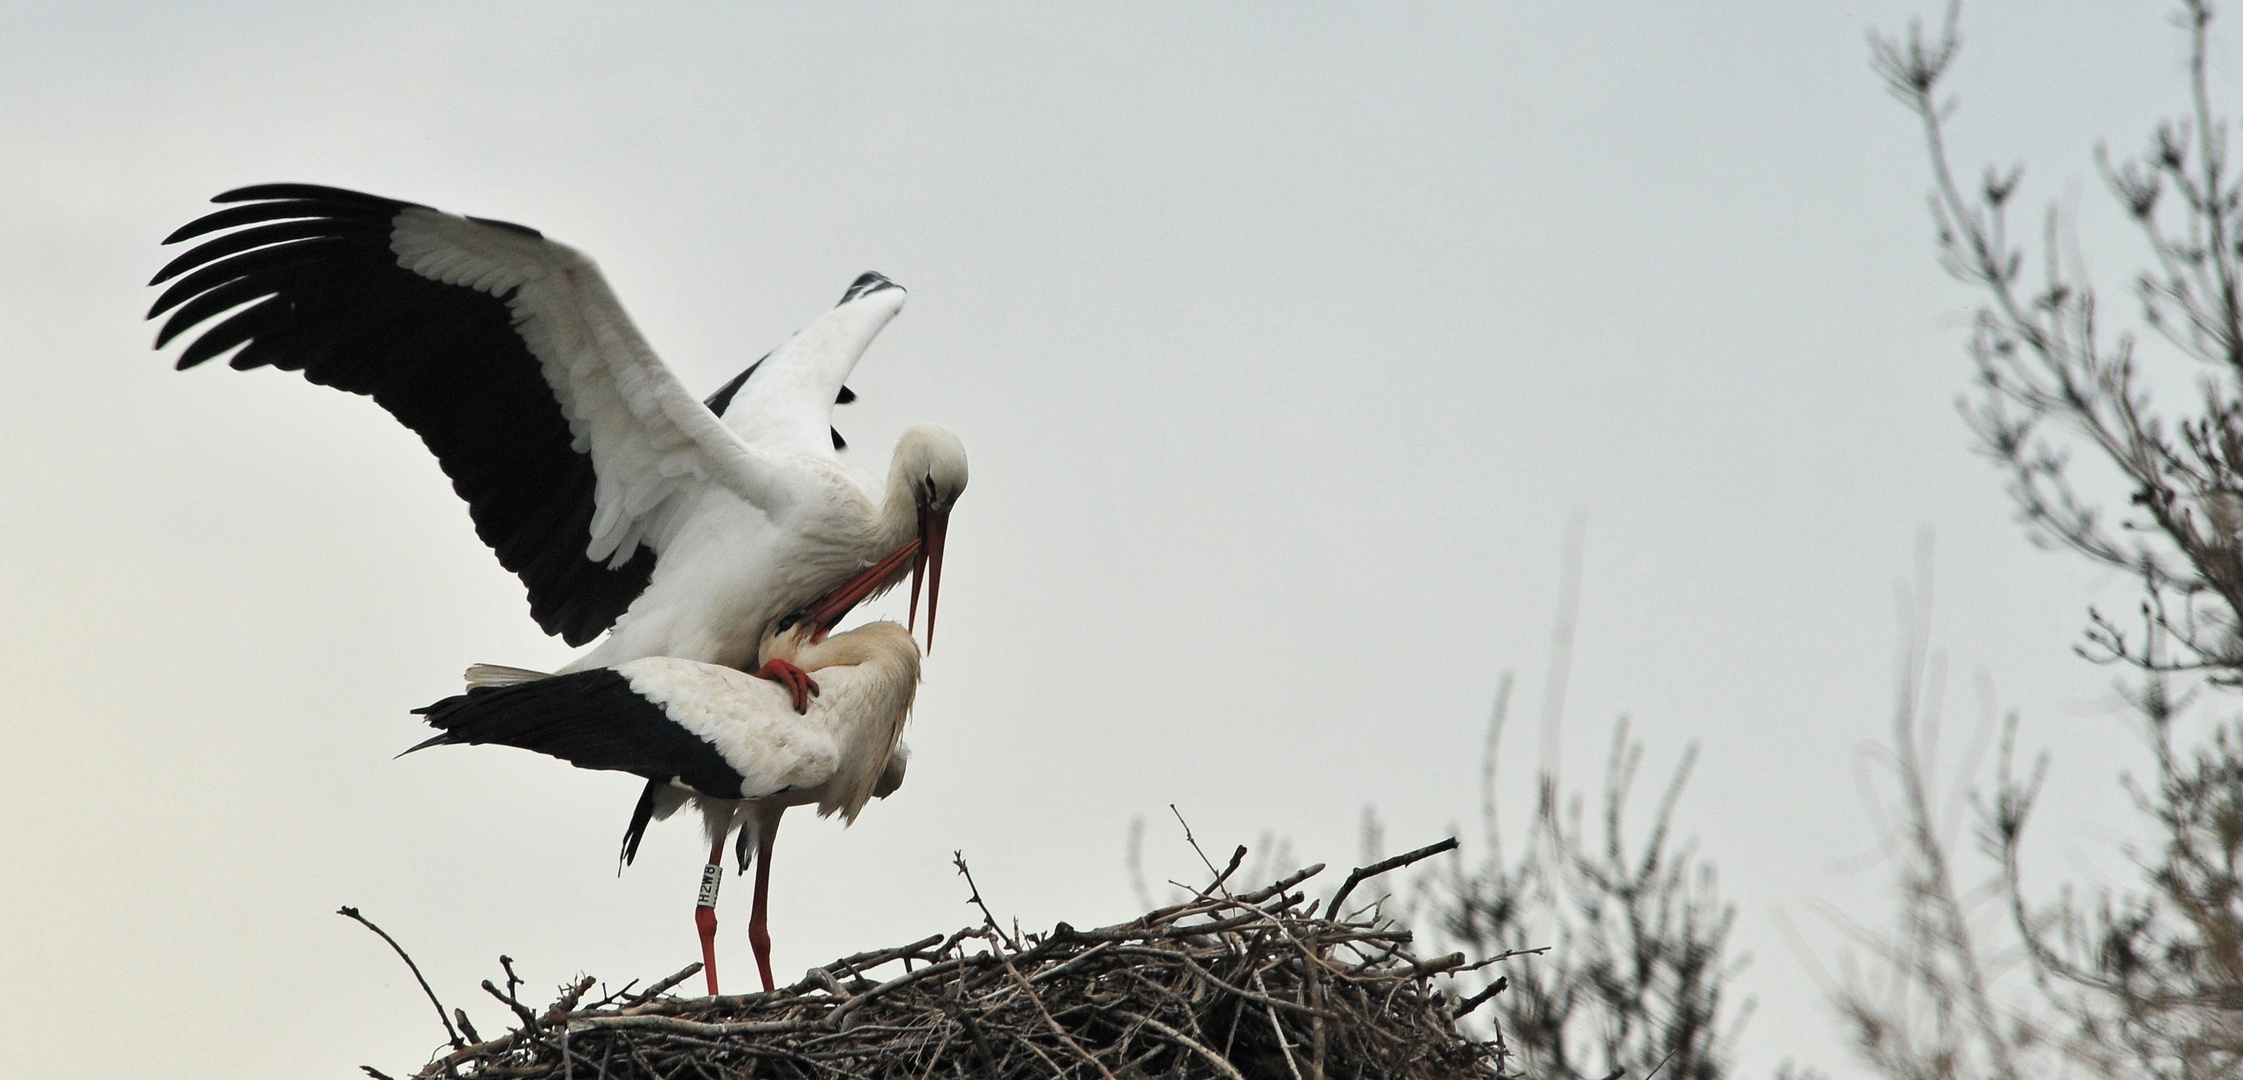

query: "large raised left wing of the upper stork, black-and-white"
left=148, top=184, right=781, bottom=644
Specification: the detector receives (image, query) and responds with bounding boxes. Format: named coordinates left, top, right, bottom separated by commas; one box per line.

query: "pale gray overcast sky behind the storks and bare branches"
left=0, top=2, right=2207, bottom=1078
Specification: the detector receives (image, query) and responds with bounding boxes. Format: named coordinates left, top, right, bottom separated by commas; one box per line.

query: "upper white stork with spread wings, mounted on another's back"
left=148, top=184, right=967, bottom=676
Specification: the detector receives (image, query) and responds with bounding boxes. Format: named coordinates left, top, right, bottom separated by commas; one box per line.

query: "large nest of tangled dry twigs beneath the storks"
left=376, top=840, right=1516, bottom=1080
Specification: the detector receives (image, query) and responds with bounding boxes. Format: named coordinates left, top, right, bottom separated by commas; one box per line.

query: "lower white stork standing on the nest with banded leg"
left=406, top=622, right=920, bottom=995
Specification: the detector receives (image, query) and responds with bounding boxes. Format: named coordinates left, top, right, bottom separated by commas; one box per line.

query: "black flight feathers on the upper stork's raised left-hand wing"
left=148, top=184, right=655, bottom=644
